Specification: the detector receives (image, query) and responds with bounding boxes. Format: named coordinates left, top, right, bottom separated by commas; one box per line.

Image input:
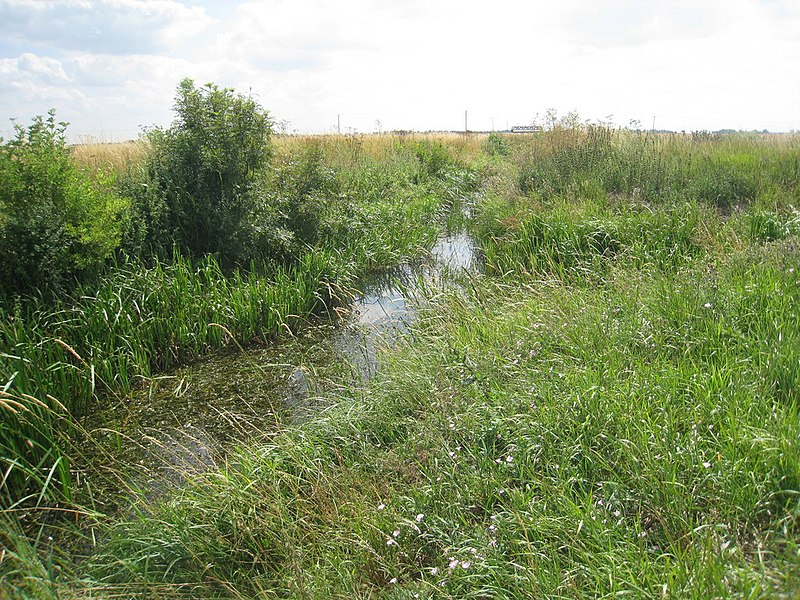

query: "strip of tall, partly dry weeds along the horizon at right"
left=509, top=127, right=800, bottom=211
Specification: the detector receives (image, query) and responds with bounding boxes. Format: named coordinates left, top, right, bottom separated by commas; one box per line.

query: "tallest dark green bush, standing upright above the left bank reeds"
left=127, top=79, right=272, bottom=264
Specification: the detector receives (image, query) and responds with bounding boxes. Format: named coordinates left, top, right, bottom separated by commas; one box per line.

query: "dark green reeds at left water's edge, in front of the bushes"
left=0, top=251, right=352, bottom=505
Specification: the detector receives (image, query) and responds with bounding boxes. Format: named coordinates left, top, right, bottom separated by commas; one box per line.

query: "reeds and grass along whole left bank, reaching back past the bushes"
left=0, top=130, right=473, bottom=506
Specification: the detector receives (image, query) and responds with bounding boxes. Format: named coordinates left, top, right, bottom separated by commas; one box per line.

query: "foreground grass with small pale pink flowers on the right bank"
left=83, top=241, right=800, bottom=598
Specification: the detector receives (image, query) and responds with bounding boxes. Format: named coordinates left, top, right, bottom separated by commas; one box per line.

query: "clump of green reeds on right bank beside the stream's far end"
left=475, top=199, right=700, bottom=283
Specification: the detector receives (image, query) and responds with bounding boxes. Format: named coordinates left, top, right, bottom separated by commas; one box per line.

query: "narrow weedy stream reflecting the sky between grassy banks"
left=79, top=227, right=476, bottom=489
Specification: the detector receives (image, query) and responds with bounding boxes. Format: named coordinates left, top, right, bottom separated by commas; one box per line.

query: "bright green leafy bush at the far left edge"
left=0, top=111, right=125, bottom=296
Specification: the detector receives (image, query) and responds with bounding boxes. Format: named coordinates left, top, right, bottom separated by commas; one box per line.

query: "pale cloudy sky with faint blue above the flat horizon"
left=0, top=0, right=800, bottom=141
